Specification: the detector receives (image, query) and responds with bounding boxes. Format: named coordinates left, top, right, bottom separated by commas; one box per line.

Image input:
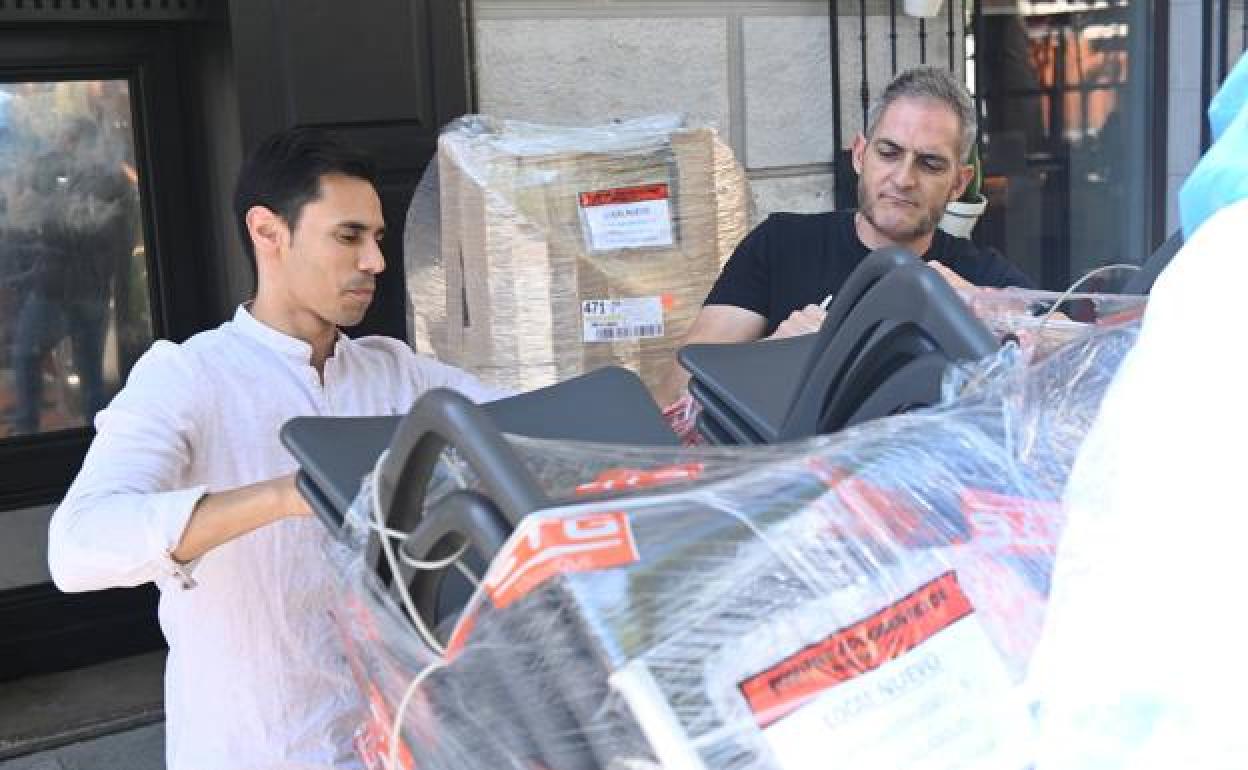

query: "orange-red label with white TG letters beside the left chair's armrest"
left=483, top=512, right=639, bottom=609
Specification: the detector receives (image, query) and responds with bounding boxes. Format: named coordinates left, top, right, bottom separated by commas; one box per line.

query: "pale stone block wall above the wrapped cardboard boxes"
left=473, top=0, right=962, bottom=217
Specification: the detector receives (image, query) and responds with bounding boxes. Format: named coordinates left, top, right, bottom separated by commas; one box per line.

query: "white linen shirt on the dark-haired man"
left=49, top=307, right=502, bottom=770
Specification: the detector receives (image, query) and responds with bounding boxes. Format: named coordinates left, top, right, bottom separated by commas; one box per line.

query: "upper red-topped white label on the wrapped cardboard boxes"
left=579, top=185, right=673, bottom=251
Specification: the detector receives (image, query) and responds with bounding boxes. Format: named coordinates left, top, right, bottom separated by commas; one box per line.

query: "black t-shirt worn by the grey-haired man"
left=705, top=211, right=1032, bottom=334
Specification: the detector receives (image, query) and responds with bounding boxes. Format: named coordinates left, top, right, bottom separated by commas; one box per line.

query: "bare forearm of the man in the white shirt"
left=170, top=475, right=308, bottom=564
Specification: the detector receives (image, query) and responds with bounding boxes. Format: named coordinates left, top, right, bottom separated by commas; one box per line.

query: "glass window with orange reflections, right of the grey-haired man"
left=975, top=0, right=1164, bottom=291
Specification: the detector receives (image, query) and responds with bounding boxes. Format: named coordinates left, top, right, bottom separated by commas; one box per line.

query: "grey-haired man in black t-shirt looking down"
left=659, top=67, right=1031, bottom=399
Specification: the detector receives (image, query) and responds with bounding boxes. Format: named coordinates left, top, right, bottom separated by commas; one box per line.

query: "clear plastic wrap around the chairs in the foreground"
left=333, top=327, right=1134, bottom=770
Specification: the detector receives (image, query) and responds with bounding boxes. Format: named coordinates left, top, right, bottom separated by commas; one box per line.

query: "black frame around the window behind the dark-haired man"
left=0, top=24, right=210, bottom=515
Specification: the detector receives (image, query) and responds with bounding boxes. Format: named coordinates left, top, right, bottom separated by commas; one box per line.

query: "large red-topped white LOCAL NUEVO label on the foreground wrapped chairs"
left=739, top=572, right=1030, bottom=770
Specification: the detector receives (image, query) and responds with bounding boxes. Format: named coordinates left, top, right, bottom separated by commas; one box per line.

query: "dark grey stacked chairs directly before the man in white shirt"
left=282, top=367, right=679, bottom=643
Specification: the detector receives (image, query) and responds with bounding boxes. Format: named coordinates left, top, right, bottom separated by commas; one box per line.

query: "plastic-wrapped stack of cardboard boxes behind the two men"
left=404, top=116, right=750, bottom=399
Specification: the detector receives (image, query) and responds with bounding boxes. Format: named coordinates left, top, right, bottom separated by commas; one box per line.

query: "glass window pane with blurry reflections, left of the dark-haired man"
left=0, top=80, right=152, bottom=441
